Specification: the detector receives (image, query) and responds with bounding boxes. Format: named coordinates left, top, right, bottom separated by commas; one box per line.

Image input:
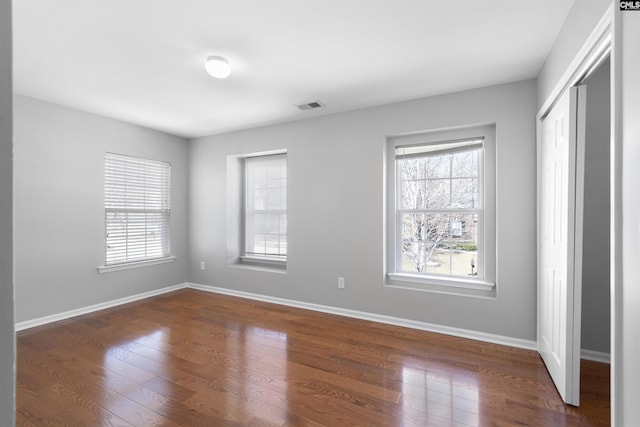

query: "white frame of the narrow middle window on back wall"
left=240, top=152, right=288, bottom=268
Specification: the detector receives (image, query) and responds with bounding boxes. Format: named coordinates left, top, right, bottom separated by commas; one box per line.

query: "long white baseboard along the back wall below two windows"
left=187, top=283, right=536, bottom=350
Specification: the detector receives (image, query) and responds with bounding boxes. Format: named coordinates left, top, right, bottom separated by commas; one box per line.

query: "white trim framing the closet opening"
left=536, top=2, right=615, bottom=408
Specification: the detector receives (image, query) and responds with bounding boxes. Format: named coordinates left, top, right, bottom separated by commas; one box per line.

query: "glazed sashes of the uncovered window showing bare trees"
left=395, top=137, right=485, bottom=280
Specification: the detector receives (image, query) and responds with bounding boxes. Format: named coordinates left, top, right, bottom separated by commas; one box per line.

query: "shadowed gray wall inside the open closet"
left=582, top=60, right=611, bottom=353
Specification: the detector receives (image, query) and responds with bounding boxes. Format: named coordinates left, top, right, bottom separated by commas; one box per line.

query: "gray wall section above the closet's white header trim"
left=538, top=0, right=618, bottom=108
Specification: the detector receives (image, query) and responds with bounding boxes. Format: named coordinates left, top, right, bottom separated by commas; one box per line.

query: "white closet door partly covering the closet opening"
left=538, top=88, right=586, bottom=406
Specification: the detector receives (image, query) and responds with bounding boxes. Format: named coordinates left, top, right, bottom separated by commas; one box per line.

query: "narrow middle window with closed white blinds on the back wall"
left=242, top=154, right=287, bottom=265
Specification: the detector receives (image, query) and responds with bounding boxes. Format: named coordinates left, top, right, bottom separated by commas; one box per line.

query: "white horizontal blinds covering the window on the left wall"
left=105, top=153, right=171, bottom=265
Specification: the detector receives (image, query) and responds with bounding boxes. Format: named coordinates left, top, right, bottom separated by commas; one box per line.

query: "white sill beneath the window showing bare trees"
left=385, top=273, right=496, bottom=297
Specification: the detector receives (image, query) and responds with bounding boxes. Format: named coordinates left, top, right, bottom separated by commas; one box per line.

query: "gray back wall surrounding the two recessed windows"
left=189, top=81, right=536, bottom=340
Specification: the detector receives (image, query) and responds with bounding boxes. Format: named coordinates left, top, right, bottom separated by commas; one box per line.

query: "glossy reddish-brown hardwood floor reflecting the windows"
left=16, top=289, right=610, bottom=426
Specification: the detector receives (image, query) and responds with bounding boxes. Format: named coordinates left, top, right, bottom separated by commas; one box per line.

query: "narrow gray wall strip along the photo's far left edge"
left=0, top=0, right=15, bottom=426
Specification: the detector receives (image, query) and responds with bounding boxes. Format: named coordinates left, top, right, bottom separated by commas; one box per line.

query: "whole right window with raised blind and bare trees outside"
left=388, top=123, right=495, bottom=290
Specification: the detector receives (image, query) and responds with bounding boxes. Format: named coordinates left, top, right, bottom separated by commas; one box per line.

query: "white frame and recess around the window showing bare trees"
left=385, top=125, right=496, bottom=296
